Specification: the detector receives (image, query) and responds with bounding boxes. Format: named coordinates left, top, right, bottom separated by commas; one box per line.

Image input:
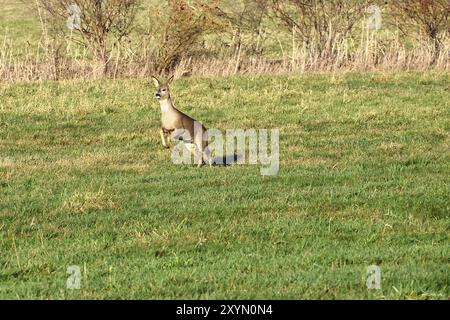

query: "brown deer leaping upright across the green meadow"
left=152, top=76, right=212, bottom=167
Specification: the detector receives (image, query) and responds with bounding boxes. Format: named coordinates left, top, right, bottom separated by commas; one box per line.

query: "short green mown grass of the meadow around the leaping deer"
left=0, top=72, right=450, bottom=299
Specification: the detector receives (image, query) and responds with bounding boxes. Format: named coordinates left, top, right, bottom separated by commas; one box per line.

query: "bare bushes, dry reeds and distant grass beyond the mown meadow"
left=0, top=0, right=450, bottom=81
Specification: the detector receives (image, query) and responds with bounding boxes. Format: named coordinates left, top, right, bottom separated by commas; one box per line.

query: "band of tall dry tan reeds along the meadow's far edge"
left=0, top=24, right=450, bottom=82
